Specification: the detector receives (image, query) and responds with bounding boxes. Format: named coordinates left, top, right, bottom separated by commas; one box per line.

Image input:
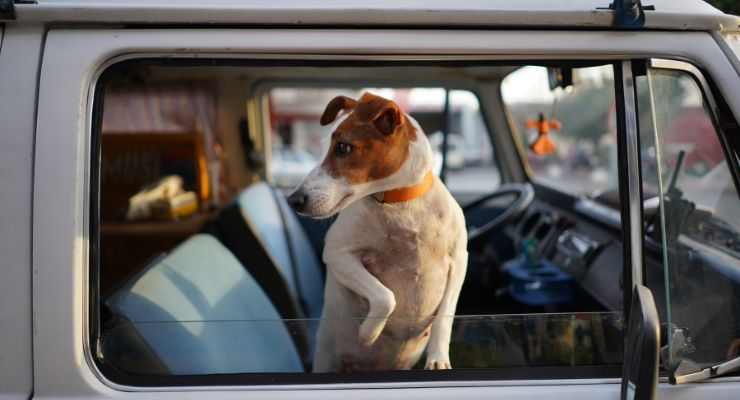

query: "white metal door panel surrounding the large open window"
left=33, top=29, right=740, bottom=400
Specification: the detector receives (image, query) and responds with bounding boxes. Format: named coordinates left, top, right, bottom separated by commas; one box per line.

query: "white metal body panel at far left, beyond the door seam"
left=0, top=22, right=43, bottom=399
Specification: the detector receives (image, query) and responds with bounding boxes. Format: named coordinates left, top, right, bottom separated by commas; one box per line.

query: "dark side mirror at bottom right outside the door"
left=620, top=285, right=660, bottom=400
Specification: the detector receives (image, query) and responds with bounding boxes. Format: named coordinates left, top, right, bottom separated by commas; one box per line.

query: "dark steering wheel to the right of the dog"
left=463, top=183, right=534, bottom=249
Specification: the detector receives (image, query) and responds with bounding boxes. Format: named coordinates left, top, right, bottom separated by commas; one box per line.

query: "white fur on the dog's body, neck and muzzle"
left=298, top=110, right=467, bottom=372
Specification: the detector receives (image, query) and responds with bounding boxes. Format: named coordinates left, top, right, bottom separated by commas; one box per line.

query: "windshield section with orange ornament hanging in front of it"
left=501, top=65, right=617, bottom=195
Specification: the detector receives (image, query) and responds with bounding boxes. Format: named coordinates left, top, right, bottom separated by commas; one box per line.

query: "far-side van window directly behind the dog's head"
left=267, top=87, right=501, bottom=197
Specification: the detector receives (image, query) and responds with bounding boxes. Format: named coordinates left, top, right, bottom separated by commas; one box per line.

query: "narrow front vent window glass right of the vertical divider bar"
left=637, top=69, right=740, bottom=366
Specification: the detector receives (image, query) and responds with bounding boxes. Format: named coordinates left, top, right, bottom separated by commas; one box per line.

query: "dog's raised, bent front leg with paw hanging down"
left=324, top=249, right=396, bottom=346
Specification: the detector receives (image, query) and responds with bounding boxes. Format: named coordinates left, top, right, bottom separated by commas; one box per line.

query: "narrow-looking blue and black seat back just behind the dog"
left=201, top=182, right=324, bottom=365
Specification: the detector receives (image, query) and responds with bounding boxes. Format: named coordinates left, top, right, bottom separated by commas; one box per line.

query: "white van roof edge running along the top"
left=15, top=0, right=740, bottom=31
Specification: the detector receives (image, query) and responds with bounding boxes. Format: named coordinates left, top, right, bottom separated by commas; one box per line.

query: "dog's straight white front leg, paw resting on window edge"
left=424, top=248, right=468, bottom=369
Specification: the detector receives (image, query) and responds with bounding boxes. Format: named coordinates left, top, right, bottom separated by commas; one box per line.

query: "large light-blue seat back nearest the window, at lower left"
left=106, top=234, right=304, bottom=375
